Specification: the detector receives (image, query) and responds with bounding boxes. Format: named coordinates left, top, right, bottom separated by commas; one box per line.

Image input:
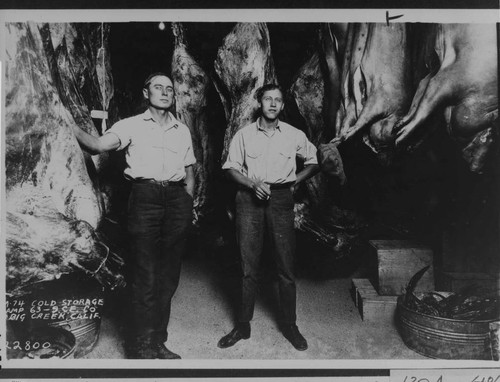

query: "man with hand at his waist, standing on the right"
left=218, top=84, right=319, bottom=350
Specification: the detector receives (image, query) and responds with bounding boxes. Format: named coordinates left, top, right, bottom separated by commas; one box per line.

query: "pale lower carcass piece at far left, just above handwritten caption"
left=6, top=209, right=124, bottom=296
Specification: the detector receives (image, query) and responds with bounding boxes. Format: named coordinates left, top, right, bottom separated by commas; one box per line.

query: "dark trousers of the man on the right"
left=236, top=189, right=296, bottom=324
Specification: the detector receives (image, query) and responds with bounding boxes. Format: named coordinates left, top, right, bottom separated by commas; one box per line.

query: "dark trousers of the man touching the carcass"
left=128, top=183, right=193, bottom=342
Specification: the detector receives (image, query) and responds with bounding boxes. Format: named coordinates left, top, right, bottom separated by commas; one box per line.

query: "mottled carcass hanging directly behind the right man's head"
left=215, top=23, right=277, bottom=158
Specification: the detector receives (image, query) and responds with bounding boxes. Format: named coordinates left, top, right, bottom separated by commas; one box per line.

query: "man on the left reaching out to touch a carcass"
left=74, top=73, right=196, bottom=359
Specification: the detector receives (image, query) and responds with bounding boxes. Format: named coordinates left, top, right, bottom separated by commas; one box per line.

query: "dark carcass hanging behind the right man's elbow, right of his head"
left=290, top=24, right=359, bottom=258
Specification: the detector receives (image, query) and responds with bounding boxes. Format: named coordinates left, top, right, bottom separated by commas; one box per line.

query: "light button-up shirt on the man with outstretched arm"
left=106, top=109, right=196, bottom=181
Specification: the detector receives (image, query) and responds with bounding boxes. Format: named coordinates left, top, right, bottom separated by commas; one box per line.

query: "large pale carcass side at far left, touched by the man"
left=5, top=23, right=102, bottom=227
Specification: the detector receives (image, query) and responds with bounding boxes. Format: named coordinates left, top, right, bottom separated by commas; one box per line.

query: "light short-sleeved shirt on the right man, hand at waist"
left=222, top=120, right=318, bottom=184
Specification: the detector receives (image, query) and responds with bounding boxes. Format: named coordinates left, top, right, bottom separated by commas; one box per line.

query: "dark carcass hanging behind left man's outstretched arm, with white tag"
left=40, top=23, right=114, bottom=211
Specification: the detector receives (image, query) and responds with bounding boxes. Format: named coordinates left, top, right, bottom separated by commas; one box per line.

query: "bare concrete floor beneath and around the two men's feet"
left=85, top=254, right=426, bottom=360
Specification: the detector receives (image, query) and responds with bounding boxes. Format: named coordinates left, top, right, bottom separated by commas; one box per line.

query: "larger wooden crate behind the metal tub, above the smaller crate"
left=370, top=240, right=434, bottom=296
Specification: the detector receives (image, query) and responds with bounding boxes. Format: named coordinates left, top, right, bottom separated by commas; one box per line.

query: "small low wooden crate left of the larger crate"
left=358, top=280, right=397, bottom=322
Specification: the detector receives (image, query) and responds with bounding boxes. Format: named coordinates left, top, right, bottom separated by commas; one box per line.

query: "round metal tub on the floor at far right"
left=396, top=296, right=494, bottom=360
